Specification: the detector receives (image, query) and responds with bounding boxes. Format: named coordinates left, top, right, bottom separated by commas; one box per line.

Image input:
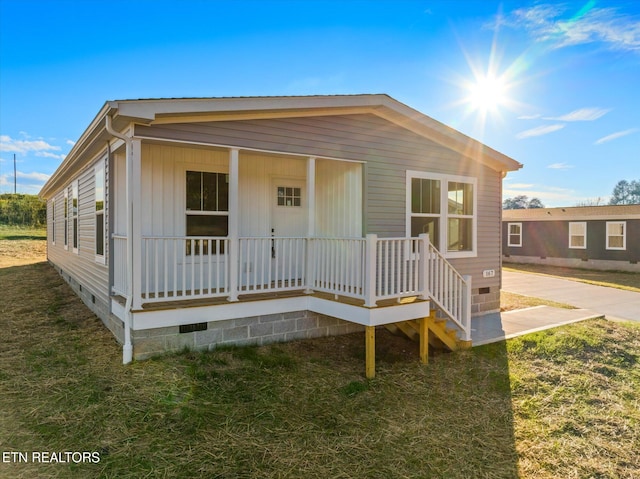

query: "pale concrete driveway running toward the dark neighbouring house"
left=502, top=270, right=640, bottom=321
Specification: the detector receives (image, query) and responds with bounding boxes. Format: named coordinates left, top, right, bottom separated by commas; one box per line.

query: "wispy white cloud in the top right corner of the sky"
left=500, top=2, right=640, bottom=53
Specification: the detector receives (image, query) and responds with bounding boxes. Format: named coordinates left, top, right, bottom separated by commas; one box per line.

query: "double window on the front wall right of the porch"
left=407, top=171, right=477, bottom=257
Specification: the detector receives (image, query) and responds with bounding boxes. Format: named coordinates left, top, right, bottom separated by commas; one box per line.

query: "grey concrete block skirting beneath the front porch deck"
left=132, top=311, right=364, bottom=359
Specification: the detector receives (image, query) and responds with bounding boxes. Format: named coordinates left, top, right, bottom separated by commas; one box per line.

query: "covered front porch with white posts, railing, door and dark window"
left=109, top=137, right=471, bottom=376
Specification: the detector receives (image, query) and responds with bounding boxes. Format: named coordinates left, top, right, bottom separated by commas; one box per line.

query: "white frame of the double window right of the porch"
left=405, top=170, right=478, bottom=258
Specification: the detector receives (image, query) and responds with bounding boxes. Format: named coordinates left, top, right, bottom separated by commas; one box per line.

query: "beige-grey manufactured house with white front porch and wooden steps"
left=40, top=95, right=521, bottom=376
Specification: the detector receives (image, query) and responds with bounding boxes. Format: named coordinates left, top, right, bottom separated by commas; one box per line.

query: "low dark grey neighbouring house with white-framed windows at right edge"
left=502, top=205, right=640, bottom=272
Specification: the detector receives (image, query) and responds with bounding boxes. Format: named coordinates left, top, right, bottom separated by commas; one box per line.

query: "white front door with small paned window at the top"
left=271, top=177, right=308, bottom=287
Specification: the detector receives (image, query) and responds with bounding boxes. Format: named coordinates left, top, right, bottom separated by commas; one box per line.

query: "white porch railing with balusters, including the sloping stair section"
left=113, top=235, right=471, bottom=340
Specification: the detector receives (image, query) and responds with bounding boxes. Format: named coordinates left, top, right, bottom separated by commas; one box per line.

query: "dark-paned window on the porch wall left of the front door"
left=186, top=171, right=229, bottom=254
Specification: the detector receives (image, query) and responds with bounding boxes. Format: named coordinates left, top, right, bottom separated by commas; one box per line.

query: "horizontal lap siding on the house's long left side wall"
left=47, top=154, right=110, bottom=320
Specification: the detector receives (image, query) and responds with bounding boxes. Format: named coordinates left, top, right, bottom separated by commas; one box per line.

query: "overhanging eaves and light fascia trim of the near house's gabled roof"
left=40, top=94, right=522, bottom=198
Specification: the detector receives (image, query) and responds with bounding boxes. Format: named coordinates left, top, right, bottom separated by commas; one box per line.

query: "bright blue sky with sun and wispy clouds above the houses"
left=0, top=0, right=640, bottom=206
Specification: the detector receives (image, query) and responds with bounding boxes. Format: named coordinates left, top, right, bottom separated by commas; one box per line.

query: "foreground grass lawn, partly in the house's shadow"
left=0, top=263, right=640, bottom=479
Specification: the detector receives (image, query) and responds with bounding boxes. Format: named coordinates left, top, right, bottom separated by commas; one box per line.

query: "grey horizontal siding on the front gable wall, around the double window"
left=136, top=114, right=502, bottom=312
